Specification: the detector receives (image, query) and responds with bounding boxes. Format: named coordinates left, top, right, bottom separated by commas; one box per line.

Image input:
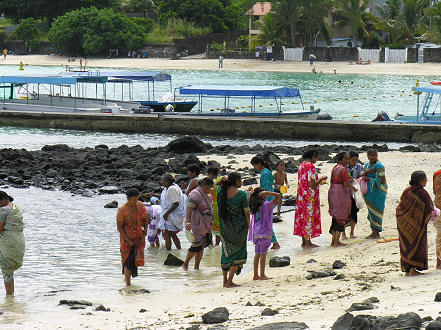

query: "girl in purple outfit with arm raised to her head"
left=248, top=188, right=282, bottom=281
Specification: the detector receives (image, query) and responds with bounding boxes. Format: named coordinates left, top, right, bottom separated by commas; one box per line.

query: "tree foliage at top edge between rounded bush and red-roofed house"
left=159, top=0, right=243, bottom=32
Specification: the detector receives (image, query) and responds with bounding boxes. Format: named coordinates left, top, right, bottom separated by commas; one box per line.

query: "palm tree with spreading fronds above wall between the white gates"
left=334, top=0, right=378, bottom=47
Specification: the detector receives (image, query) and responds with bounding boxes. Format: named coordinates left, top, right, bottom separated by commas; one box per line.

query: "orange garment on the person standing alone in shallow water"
left=117, top=202, right=147, bottom=277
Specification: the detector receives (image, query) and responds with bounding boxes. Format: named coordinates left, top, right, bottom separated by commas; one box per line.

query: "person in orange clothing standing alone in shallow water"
left=116, top=188, right=150, bottom=286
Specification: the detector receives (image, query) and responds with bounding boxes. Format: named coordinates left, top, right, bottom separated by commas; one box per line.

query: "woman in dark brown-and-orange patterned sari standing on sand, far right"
left=396, top=171, right=434, bottom=276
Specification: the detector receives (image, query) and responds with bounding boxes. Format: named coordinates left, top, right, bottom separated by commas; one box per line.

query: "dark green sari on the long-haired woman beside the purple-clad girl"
left=218, top=191, right=249, bottom=273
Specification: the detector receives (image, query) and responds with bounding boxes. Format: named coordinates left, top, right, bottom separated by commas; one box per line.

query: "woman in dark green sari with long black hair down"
left=217, top=173, right=250, bottom=288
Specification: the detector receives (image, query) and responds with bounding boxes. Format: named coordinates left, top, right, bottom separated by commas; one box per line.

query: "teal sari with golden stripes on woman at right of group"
left=364, top=162, right=387, bottom=232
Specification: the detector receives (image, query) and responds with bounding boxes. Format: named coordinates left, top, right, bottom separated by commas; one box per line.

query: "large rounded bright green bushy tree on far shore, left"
left=48, top=7, right=145, bottom=55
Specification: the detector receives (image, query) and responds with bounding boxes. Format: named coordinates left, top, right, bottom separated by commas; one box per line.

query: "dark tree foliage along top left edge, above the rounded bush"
left=0, top=0, right=121, bottom=23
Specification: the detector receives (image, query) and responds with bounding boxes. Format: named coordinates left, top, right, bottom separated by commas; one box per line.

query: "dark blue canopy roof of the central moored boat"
left=179, top=85, right=300, bottom=98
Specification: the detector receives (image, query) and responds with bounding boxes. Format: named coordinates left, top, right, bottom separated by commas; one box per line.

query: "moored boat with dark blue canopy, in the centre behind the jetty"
left=170, top=85, right=321, bottom=119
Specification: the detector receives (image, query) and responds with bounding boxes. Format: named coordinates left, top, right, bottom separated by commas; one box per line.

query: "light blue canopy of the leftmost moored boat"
left=0, top=75, right=107, bottom=85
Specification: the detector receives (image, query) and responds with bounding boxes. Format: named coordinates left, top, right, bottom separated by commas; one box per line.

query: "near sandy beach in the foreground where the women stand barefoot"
left=17, top=152, right=441, bottom=329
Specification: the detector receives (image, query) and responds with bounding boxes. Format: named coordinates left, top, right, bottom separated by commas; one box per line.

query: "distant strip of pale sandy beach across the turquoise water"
left=0, top=55, right=441, bottom=76
